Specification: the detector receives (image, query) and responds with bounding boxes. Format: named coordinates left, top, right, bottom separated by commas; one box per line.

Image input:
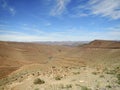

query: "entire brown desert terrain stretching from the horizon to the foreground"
left=0, top=40, right=120, bottom=90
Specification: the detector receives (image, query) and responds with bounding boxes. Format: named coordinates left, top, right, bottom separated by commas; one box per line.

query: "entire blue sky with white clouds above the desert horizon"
left=0, top=0, right=120, bottom=42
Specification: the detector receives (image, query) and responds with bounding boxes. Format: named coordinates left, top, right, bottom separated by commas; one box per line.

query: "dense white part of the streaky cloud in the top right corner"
left=88, top=0, right=120, bottom=19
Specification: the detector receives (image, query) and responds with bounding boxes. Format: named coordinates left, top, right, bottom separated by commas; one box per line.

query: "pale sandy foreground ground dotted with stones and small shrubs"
left=1, top=65, right=120, bottom=90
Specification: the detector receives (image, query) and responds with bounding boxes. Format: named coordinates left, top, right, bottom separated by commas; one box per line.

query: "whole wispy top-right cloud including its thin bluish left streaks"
left=73, top=0, right=120, bottom=20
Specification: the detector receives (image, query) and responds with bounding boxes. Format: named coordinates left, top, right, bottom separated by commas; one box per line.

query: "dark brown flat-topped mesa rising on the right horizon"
left=83, top=40, right=120, bottom=49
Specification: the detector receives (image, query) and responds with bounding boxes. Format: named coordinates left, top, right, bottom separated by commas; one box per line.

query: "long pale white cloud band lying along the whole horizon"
left=0, top=27, right=120, bottom=41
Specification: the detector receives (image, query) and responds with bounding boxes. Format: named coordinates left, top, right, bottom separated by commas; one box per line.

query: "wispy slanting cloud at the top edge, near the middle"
left=50, top=0, right=71, bottom=16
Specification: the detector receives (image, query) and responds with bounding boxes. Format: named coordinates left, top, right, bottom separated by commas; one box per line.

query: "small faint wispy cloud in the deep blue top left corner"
left=1, top=0, right=16, bottom=16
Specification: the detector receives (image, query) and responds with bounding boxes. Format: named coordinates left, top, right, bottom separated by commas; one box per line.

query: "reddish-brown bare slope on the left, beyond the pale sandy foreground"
left=0, top=41, right=71, bottom=78
